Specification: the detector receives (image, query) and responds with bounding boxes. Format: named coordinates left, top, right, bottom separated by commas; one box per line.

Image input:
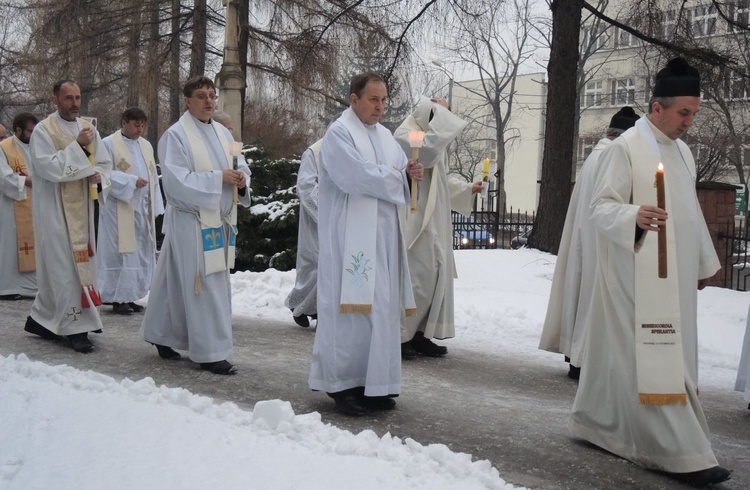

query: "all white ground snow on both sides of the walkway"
left=0, top=250, right=750, bottom=490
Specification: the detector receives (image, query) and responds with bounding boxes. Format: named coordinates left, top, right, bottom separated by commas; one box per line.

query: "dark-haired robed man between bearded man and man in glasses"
left=96, top=107, right=164, bottom=314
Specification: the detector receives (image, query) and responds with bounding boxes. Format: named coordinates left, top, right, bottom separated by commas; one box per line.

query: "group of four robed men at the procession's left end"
left=0, top=77, right=250, bottom=374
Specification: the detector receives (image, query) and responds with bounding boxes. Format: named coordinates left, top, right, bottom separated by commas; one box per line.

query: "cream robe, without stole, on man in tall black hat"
left=570, top=117, right=719, bottom=473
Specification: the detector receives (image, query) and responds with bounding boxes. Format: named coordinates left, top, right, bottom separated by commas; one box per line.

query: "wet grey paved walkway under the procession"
left=0, top=300, right=750, bottom=489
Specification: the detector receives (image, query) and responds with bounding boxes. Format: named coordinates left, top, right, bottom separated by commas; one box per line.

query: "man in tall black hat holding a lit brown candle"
left=570, top=58, right=729, bottom=485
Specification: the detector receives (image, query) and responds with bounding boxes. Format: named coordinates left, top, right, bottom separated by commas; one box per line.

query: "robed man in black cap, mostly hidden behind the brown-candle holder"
left=539, top=107, right=638, bottom=379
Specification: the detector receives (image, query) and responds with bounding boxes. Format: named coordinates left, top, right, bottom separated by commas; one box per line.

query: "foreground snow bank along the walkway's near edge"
left=0, top=354, right=514, bottom=490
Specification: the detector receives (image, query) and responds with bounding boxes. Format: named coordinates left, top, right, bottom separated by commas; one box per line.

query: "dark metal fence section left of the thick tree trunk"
left=451, top=190, right=534, bottom=249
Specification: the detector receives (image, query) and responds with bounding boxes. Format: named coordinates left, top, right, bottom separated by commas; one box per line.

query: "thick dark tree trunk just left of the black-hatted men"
left=529, top=0, right=583, bottom=254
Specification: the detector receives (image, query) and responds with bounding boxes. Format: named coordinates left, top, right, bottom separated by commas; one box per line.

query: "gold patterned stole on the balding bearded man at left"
left=42, top=114, right=102, bottom=308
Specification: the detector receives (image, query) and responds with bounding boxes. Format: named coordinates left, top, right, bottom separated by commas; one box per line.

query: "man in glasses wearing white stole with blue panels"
left=141, top=76, right=250, bottom=375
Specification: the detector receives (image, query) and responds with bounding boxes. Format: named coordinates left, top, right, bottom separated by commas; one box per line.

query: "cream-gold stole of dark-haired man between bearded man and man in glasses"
left=112, top=130, right=156, bottom=254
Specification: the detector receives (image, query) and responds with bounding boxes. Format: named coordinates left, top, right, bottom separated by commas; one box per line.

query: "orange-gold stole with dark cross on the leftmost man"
left=0, top=138, right=36, bottom=272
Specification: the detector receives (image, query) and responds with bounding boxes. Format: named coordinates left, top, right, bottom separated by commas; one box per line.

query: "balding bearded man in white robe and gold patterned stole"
left=25, top=80, right=112, bottom=353
